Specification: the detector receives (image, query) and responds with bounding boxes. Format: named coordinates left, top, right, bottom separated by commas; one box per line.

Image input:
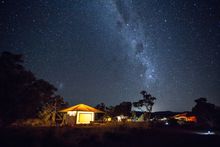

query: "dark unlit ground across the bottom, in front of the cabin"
left=0, top=126, right=220, bottom=147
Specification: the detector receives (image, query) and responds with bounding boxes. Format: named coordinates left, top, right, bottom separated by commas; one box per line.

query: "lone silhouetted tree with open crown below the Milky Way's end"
left=133, top=90, right=156, bottom=121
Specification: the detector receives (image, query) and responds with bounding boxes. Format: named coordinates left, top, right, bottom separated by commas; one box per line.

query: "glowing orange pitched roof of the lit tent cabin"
left=59, top=104, right=104, bottom=113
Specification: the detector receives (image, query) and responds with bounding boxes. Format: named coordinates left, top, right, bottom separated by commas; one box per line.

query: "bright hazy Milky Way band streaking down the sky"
left=111, top=1, right=156, bottom=87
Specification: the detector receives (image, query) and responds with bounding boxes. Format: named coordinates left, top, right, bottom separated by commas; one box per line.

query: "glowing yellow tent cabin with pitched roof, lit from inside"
left=59, top=104, right=104, bottom=124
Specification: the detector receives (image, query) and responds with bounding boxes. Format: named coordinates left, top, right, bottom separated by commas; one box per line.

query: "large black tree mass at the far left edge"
left=0, top=52, right=67, bottom=124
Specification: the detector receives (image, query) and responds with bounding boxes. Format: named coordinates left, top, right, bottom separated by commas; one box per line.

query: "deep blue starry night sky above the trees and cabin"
left=0, top=0, right=220, bottom=111
